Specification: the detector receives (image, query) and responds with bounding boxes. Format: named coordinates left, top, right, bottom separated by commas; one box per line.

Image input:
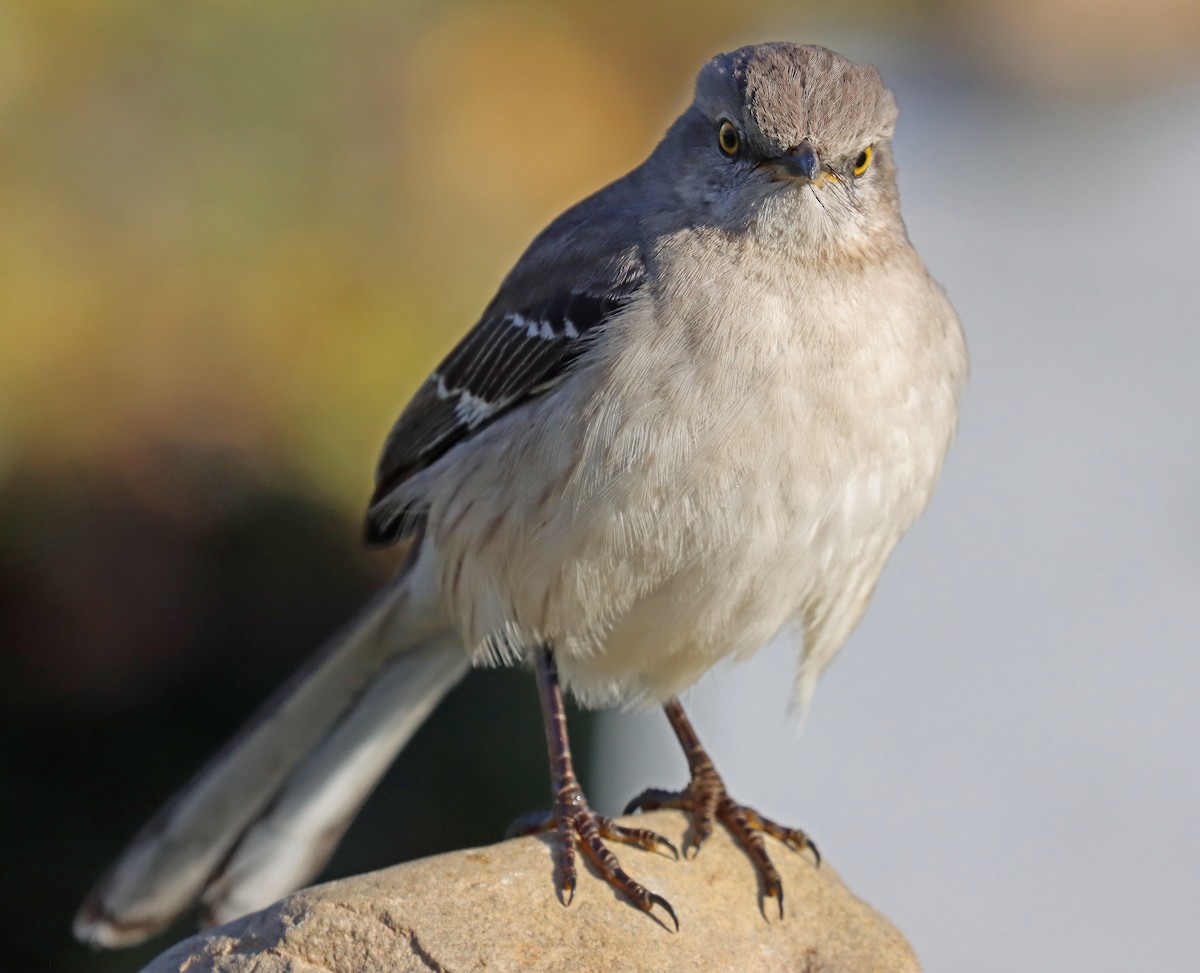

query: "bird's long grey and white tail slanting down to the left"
left=74, top=581, right=468, bottom=947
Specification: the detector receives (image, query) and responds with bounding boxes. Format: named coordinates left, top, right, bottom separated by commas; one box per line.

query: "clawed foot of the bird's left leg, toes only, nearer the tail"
left=509, top=783, right=679, bottom=931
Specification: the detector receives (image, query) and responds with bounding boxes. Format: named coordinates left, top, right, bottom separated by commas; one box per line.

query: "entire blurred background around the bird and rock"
left=0, top=0, right=1200, bottom=973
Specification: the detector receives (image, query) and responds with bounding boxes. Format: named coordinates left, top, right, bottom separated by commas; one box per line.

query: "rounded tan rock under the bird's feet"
left=145, top=811, right=919, bottom=973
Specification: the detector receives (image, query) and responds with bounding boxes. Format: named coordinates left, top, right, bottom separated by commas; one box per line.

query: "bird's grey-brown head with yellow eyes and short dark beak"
left=655, top=43, right=904, bottom=259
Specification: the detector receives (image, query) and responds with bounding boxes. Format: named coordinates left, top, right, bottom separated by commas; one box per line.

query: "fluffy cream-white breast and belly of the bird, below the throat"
left=412, top=243, right=961, bottom=704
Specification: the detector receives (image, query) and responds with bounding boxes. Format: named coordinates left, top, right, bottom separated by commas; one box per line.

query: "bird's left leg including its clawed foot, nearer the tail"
left=509, top=647, right=679, bottom=930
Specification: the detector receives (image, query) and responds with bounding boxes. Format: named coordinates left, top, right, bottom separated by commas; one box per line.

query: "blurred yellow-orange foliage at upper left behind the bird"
left=0, top=0, right=768, bottom=509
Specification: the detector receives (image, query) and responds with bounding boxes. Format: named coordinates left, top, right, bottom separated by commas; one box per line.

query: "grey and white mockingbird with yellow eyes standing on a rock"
left=76, top=43, right=967, bottom=945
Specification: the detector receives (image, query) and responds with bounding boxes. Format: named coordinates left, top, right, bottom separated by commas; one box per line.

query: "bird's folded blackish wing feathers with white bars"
left=366, top=248, right=646, bottom=543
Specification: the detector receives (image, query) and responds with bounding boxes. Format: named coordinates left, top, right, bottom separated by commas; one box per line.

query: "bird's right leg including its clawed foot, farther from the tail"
left=625, top=699, right=821, bottom=915
